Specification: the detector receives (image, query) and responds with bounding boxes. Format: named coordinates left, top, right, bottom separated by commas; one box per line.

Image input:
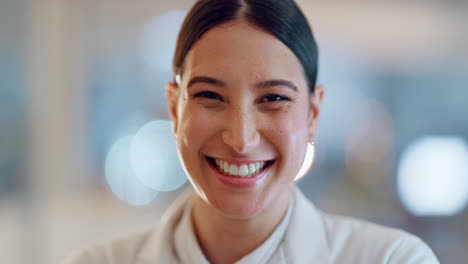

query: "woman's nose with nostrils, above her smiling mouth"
left=221, top=111, right=260, bottom=154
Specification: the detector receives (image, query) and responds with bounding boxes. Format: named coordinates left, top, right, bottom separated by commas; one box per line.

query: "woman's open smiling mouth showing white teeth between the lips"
left=206, top=157, right=274, bottom=178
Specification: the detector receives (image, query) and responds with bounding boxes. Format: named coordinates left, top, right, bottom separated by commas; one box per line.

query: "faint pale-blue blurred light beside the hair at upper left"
left=140, top=10, right=187, bottom=73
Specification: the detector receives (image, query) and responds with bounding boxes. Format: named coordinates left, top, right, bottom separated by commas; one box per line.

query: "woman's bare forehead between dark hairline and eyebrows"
left=184, top=21, right=303, bottom=84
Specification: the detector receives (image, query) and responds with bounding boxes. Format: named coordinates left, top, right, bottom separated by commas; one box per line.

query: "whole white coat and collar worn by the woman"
left=65, top=188, right=439, bottom=264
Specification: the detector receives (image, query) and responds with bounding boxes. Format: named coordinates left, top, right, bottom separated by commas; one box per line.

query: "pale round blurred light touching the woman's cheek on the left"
left=130, top=120, right=187, bottom=191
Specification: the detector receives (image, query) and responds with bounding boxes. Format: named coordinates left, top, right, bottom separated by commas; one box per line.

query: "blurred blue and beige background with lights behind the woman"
left=0, top=0, right=468, bottom=264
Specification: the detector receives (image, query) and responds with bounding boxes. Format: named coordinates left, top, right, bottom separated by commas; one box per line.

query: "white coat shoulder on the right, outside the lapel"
left=321, top=212, right=439, bottom=264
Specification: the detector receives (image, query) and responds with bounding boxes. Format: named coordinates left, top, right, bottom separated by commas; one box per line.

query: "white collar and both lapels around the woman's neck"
left=138, top=187, right=330, bottom=264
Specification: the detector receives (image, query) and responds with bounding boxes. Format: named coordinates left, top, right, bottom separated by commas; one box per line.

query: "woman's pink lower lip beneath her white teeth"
left=205, top=159, right=272, bottom=188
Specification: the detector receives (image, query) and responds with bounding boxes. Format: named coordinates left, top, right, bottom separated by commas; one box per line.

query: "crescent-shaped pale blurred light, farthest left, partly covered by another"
left=105, top=136, right=158, bottom=206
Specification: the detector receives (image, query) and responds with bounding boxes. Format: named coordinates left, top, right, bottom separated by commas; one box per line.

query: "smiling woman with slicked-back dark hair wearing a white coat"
left=65, top=0, right=438, bottom=264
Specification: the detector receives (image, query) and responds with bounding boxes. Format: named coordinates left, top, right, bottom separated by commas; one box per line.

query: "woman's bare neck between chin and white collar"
left=192, top=190, right=290, bottom=264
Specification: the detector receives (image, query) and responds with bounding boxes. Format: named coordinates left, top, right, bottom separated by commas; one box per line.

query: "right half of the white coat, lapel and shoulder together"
left=287, top=188, right=439, bottom=264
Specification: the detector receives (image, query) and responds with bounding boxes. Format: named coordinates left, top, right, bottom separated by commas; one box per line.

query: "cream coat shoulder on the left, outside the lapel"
left=63, top=229, right=154, bottom=264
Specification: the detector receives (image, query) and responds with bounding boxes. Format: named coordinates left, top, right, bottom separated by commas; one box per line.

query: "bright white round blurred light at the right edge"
left=398, top=136, right=468, bottom=216
